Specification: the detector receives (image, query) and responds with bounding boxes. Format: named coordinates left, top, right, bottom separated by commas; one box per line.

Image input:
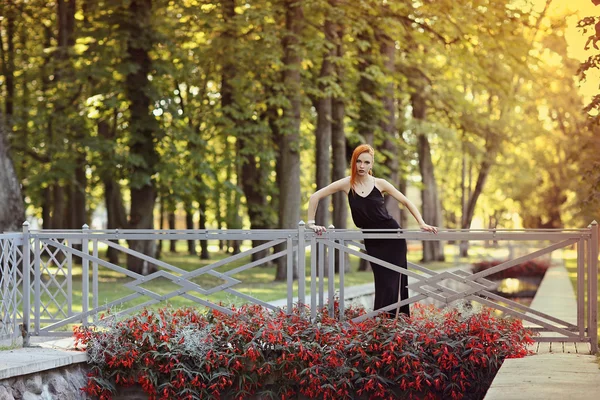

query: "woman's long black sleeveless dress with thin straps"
left=348, top=187, right=410, bottom=315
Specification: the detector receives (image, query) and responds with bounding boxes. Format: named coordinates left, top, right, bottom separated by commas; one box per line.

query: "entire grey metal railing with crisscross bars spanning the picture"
left=0, top=222, right=598, bottom=353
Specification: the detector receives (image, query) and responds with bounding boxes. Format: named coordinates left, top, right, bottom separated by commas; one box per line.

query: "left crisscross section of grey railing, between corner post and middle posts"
left=22, top=229, right=297, bottom=335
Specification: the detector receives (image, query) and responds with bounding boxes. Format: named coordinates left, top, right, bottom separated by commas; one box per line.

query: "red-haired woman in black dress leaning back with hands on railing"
left=307, top=144, right=437, bottom=315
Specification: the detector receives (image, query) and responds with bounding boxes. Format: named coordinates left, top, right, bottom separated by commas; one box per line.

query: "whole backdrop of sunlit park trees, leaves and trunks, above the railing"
left=0, top=0, right=600, bottom=279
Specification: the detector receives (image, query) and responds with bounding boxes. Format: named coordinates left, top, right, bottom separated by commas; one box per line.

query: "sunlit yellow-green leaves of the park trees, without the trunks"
left=0, top=0, right=600, bottom=234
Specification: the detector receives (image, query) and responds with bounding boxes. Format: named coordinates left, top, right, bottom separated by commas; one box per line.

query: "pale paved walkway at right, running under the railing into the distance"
left=485, top=266, right=600, bottom=400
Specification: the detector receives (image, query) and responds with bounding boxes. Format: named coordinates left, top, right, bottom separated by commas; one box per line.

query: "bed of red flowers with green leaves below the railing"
left=75, top=305, right=533, bottom=399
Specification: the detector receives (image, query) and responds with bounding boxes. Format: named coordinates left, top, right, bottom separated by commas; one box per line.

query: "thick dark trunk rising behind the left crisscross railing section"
left=122, top=0, right=160, bottom=274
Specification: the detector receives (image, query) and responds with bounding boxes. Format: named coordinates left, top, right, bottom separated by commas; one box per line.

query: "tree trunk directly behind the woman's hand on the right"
left=411, top=89, right=444, bottom=262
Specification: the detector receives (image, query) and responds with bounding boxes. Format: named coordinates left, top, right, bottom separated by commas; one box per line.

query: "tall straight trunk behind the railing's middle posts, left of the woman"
left=275, top=0, right=304, bottom=281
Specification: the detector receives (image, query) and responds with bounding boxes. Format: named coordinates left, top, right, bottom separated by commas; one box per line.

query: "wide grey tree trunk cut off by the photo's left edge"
left=0, top=111, right=25, bottom=233
